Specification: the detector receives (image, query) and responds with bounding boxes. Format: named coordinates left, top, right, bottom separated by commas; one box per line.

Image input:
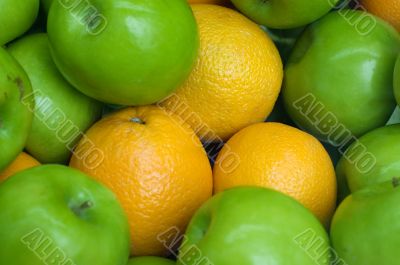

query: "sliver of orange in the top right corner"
left=360, top=0, right=400, bottom=31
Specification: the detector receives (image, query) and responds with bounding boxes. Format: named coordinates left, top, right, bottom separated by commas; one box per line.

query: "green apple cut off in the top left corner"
left=0, top=0, right=39, bottom=46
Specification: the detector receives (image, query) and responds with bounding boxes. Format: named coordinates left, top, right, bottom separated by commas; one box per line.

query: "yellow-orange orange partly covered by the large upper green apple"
left=161, top=5, right=283, bottom=141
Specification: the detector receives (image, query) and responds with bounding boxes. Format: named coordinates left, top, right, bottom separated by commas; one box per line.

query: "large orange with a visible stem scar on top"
left=70, top=106, right=212, bottom=256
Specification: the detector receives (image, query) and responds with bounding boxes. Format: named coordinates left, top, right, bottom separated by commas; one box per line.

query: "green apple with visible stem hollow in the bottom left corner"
left=0, top=165, right=130, bottom=265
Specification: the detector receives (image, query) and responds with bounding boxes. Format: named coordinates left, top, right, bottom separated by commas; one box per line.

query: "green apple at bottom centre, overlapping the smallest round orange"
left=178, top=187, right=330, bottom=265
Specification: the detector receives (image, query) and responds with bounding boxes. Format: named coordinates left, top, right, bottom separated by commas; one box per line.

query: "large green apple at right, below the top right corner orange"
left=282, top=11, right=400, bottom=144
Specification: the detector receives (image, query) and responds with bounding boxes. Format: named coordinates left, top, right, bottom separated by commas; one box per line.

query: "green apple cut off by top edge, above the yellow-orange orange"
left=232, top=0, right=338, bottom=29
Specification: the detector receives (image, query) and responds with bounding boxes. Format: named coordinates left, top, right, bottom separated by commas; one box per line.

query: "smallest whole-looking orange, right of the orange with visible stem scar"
left=214, top=122, right=337, bottom=226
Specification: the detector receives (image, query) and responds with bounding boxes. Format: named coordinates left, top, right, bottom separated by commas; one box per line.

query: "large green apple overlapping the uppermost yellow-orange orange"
left=47, top=0, right=199, bottom=105
